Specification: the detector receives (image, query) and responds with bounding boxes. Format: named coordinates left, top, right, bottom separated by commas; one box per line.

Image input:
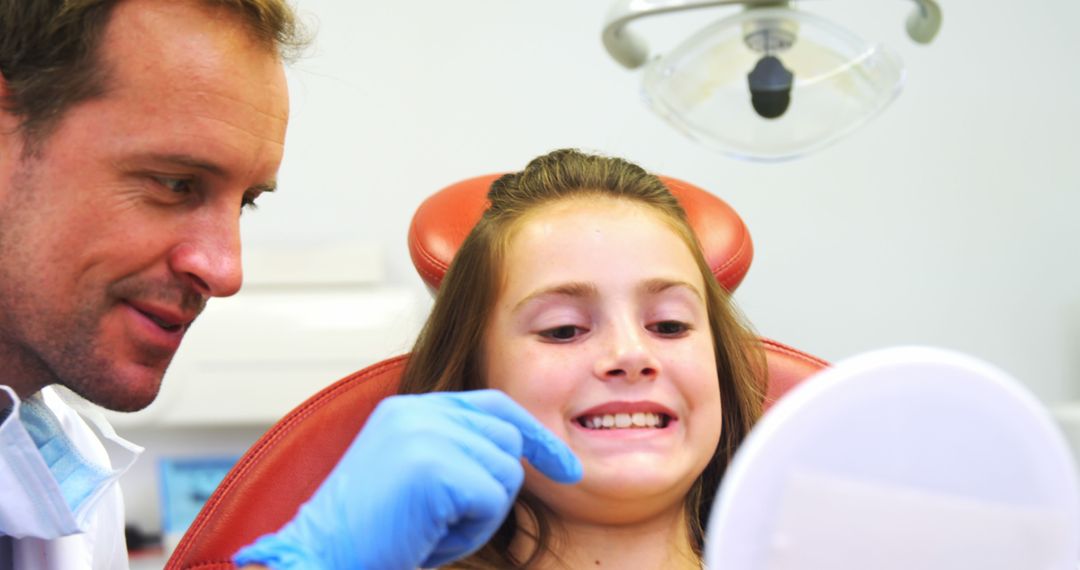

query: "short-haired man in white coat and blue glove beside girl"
left=0, top=0, right=580, bottom=570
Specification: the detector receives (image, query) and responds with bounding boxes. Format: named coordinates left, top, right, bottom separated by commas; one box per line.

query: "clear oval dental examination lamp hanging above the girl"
left=603, top=0, right=942, bottom=161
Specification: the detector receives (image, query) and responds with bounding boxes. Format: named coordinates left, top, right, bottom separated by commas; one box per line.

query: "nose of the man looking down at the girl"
left=170, top=209, right=244, bottom=297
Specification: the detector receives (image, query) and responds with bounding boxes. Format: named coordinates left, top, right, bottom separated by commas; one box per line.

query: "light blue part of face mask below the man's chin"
left=19, top=401, right=113, bottom=513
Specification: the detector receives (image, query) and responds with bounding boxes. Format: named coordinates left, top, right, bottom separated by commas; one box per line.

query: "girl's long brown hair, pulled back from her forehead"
left=400, top=149, right=765, bottom=569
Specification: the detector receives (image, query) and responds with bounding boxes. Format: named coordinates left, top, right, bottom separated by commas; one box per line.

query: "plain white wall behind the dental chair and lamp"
left=245, top=0, right=1080, bottom=403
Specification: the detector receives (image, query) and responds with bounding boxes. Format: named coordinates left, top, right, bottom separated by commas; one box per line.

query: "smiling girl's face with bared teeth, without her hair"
left=484, top=198, right=720, bottom=523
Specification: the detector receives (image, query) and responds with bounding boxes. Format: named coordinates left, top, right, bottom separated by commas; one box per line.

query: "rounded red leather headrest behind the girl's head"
left=408, top=174, right=754, bottom=291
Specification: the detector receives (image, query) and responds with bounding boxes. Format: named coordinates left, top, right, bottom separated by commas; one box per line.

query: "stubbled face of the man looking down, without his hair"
left=0, top=0, right=288, bottom=410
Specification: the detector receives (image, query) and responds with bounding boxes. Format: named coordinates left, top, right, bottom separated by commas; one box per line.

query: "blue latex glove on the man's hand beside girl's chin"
left=233, top=390, right=581, bottom=570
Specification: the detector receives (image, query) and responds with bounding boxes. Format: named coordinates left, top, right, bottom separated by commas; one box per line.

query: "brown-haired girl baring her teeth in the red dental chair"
left=401, top=150, right=765, bottom=568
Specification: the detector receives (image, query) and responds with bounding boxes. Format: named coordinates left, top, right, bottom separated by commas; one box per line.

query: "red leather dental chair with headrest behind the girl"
left=165, top=175, right=827, bottom=570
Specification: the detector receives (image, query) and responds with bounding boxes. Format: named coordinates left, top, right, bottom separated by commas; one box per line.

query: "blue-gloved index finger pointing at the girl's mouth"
left=453, top=390, right=582, bottom=483
